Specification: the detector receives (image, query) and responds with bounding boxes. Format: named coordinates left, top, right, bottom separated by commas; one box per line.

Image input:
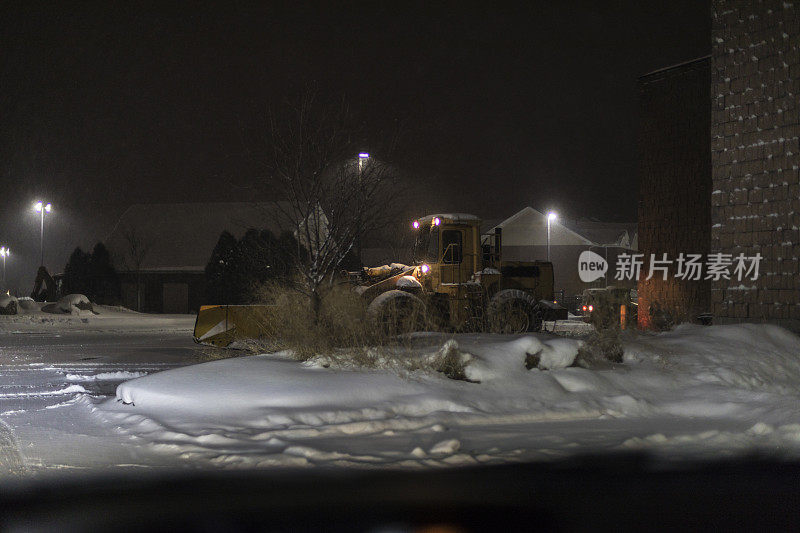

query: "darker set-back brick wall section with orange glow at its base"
left=636, top=58, right=711, bottom=327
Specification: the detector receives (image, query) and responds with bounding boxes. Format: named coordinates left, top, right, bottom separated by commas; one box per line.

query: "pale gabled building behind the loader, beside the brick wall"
left=483, top=207, right=638, bottom=296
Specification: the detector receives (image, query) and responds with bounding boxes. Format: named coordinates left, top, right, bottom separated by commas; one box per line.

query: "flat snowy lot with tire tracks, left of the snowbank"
left=0, top=310, right=198, bottom=478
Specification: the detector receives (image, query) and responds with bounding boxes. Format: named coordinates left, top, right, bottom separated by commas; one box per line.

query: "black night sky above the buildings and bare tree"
left=0, top=0, right=710, bottom=292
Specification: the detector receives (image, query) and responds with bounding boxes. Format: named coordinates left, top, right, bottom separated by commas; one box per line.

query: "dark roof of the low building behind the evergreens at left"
left=106, top=202, right=292, bottom=271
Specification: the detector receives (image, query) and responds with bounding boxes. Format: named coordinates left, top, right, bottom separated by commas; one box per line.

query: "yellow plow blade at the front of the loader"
left=194, top=305, right=277, bottom=348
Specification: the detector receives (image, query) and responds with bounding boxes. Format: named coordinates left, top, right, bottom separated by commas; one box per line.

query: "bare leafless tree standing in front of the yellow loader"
left=264, top=89, right=400, bottom=316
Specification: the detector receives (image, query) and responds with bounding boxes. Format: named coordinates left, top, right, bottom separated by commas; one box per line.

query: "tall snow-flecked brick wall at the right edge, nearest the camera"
left=712, top=0, right=800, bottom=331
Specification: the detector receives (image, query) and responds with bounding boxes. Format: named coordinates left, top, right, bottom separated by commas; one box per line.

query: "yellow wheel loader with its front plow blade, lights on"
left=194, top=214, right=553, bottom=346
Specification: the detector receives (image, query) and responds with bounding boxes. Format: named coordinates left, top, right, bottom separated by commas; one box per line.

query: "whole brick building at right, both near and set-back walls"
left=639, top=0, right=800, bottom=331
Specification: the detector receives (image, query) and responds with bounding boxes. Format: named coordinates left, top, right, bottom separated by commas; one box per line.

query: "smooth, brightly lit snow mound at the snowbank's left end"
left=112, top=356, right=462, bottom=423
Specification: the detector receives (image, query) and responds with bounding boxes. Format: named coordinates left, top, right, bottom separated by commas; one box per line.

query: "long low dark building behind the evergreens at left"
left=106, top=203, right=290, bottom=313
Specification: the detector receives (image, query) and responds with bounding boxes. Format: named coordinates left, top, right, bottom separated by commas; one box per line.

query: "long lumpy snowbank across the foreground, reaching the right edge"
left=97, top=325, right=800, bottom=467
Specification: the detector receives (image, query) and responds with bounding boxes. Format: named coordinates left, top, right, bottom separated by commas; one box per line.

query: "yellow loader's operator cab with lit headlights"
left=413, top=213, right=482, bottom=287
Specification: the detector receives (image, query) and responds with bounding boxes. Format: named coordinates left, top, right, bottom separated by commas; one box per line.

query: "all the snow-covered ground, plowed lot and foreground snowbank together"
left=0, top=315, right=800, bottom=475
